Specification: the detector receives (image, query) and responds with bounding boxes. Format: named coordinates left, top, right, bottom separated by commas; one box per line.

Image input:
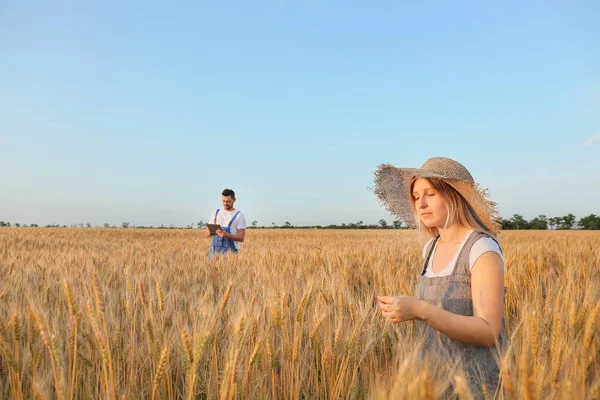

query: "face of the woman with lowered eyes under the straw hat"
left=412, top=178, right=448, bottom=228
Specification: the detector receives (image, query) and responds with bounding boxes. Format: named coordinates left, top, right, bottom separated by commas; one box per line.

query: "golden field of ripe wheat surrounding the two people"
left=0, top=228, right=600, bottom=399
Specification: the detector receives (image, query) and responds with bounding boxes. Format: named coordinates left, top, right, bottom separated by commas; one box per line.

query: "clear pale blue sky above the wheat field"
left=0, top=0, right=600, bottom=226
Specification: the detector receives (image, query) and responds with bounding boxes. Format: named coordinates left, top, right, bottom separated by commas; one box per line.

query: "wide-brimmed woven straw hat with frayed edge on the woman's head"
left=373, top=157, right=500, bottom=235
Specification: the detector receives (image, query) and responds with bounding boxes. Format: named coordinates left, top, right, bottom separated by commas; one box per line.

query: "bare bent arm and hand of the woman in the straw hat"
left=376, top=252, right=504, bottom=347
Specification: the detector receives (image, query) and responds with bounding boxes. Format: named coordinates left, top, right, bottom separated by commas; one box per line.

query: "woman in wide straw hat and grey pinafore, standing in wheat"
left=375, top=157, right=506, bottom=398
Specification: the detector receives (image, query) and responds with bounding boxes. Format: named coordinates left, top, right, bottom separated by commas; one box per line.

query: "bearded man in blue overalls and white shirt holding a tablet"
left=206, top=189, right=246, bottom=259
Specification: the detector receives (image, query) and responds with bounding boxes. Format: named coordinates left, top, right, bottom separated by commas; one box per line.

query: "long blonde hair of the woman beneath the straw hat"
left=408, top=178, right=495, bottom=238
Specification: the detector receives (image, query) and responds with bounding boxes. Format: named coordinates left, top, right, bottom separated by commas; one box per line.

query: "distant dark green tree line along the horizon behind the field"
left=0, top=213, right=600, bottom=230
